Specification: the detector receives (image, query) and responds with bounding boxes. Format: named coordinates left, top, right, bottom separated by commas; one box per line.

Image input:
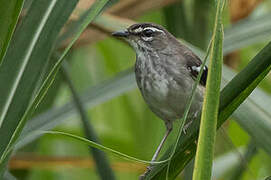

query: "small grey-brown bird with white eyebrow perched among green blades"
left=112, top=23, right=208, bottom=173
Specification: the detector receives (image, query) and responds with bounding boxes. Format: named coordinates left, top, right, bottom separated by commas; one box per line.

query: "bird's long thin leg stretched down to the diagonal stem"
left=139, top=122, right=172, bottom=180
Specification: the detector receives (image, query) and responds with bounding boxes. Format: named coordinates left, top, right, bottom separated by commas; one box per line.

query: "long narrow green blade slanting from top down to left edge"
left=0, top=0, right=108, bottom=172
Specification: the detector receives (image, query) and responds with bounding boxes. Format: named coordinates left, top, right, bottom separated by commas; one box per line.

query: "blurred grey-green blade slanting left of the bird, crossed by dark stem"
left=16, top=69, right=136, bottom=149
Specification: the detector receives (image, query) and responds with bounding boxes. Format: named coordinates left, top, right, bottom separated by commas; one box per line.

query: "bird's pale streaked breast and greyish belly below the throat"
left=135, top=59, right=203, bottom=121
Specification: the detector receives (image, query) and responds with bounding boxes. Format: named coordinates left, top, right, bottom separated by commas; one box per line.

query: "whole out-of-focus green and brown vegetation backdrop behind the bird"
left=0, top=0, right=271, bottom=180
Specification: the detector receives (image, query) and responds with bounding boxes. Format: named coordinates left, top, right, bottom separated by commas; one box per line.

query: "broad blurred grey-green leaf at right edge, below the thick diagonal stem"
left=233, top=89, right=271, bottom=155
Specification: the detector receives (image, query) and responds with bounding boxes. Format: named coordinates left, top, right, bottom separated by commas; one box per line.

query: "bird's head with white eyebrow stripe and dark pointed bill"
left=112, top=23, right=176, bottom=52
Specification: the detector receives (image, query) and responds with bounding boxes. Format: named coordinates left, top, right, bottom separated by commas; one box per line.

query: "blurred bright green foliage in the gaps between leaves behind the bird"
left=1, top=1, right=271, bottom=180
